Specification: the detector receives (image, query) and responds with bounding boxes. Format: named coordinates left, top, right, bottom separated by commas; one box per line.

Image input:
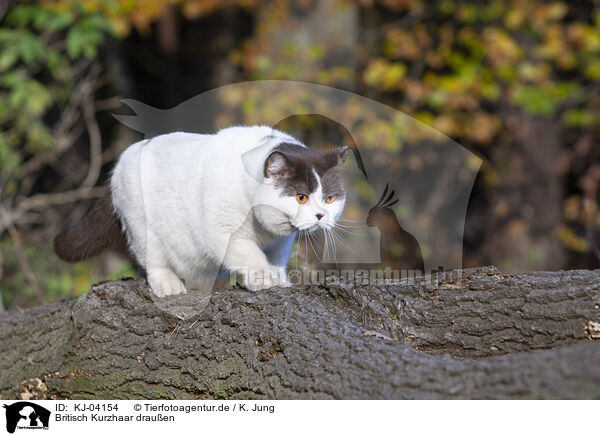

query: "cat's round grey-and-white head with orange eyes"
left=257, top=143, right=349, bottom=234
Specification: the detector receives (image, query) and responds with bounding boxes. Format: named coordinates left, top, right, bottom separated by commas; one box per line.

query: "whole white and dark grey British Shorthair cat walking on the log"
left=55, top=126, right=348, bottom=296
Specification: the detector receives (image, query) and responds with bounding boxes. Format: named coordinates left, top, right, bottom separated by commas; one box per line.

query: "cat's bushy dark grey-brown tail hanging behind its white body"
left=54, top=189, right=127, bottom=262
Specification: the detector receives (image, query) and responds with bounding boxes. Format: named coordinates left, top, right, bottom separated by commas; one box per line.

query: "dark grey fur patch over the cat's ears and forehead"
left=264, top=143, right=349, bottom=196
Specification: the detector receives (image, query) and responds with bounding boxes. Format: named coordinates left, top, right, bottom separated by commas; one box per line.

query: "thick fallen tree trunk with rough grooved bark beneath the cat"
left=0, top=268, right=600, bottom=399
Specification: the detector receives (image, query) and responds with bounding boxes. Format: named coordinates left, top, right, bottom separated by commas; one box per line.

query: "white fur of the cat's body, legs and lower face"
left=111, top=126, right=344, bottom=296
